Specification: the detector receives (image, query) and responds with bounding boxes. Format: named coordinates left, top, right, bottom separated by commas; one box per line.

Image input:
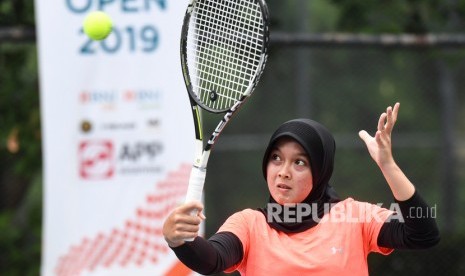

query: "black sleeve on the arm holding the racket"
left=171, top=232, right=243, bottom=275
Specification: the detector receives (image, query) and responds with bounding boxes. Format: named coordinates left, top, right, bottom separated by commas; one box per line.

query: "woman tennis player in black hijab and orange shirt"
left=163, top=103, right=439, bottom=275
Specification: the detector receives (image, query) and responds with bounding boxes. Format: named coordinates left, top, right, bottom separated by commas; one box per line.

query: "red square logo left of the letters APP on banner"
left=78, top=140, right=115, bottom=180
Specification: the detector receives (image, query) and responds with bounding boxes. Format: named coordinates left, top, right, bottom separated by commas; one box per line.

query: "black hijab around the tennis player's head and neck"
left=259, top=119, right=340, bottom=233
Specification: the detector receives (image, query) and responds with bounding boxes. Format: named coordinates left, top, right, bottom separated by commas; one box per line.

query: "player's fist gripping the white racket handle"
left=163, top=201, right=205, bottom=247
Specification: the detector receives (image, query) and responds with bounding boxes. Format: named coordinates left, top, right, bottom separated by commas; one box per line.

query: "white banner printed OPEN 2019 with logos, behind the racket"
left=35, top=0, right=194, bottom=276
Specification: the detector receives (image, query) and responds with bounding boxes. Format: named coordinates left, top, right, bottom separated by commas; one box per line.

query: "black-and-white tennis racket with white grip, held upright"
left=181, top=0, right=269, bottom=239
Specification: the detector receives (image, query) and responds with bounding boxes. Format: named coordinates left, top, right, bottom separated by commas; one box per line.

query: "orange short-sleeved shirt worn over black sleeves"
left=218, top=198, right=392, bottom=276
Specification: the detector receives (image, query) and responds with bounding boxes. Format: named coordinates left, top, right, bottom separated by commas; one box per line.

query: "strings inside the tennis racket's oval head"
left=186, top=0, right=264, bottom=110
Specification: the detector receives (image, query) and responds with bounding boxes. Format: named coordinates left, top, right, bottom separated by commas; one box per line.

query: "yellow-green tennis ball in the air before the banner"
left=83, top=11, right=113, bottom=40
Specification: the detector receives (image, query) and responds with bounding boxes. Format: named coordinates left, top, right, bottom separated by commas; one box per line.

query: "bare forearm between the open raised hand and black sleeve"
left=379, top=159, right=415, bottom=201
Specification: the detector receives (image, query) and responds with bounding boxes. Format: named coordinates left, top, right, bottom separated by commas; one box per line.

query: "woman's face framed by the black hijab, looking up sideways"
left=266, top=137, right=313, bottom=205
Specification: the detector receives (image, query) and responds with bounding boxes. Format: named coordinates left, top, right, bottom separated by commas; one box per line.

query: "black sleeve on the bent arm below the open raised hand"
left=378, top=191, right=440, bottom=249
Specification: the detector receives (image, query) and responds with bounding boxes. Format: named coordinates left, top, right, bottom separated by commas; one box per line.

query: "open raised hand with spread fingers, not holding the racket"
left=359, top=103, right=400, bottom=167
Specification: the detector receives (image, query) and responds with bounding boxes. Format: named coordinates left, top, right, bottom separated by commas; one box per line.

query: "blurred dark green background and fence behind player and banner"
left=0, top=0, right=465, bottom=275
